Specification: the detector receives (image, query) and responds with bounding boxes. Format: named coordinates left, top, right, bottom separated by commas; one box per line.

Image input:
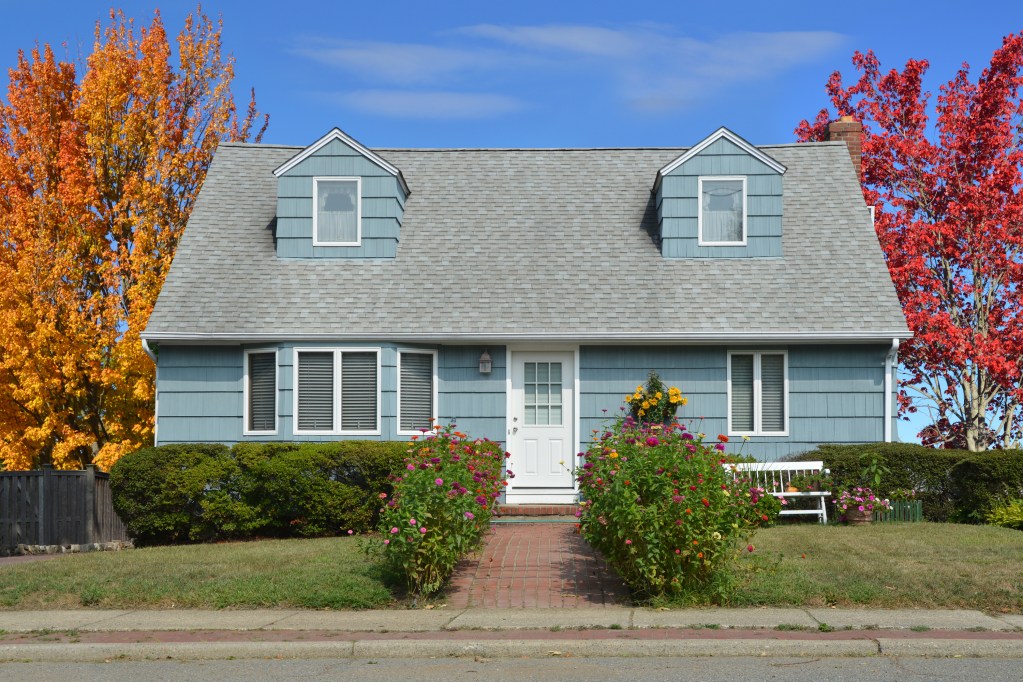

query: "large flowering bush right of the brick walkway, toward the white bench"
left=579, top=417, right=781, bottom=601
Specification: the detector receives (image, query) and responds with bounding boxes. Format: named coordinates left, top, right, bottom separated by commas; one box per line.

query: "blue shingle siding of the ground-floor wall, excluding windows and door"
left=151, top=343, right=894, bottom=460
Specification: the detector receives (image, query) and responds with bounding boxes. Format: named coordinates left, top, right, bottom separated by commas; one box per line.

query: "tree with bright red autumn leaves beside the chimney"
left=796, top=34, right=1023, bottom=451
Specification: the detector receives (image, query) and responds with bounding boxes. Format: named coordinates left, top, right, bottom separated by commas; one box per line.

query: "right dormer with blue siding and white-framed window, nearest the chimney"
left=654, top=128, right=786, bottom=258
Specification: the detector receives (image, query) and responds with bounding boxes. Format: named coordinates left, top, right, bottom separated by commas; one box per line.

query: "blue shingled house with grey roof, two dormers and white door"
left=143, top=123, right=909, bottom=502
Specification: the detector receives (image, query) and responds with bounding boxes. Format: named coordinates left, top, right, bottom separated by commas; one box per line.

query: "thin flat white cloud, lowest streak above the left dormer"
left=335, top=90, right=525, bottom=120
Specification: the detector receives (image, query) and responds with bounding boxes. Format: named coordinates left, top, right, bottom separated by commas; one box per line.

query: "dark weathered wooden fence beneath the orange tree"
left=0, top=465, right=128, bottom=549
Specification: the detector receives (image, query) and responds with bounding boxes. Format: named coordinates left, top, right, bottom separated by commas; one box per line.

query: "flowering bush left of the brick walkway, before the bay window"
left=376, top=425, right=512, bottom=597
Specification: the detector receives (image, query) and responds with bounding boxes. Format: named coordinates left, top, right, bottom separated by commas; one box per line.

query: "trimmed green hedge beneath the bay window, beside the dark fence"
left=110, top=441, right=408, bottom=545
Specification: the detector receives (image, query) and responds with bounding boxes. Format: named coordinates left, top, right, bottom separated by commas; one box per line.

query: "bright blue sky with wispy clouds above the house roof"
left=0, top=0, right=1010, bottom=439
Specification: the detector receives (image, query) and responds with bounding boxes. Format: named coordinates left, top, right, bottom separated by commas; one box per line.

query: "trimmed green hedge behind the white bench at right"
left=793, top=443, right=1023, bottom=524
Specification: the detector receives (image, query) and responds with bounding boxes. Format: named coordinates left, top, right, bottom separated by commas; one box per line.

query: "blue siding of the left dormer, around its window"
left=275, top=140, right=405, bottom=258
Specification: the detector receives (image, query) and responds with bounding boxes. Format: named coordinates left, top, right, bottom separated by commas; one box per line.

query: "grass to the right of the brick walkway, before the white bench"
left=731, top=522, right=1023, bottom=613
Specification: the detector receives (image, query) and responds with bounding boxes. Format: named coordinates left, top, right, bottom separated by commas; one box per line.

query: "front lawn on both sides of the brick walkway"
left=0, top=524, right=1023, bottom=613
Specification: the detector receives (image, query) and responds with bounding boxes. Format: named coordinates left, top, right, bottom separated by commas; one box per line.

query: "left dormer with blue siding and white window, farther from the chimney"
left=273, top=128, right=409, bottom=258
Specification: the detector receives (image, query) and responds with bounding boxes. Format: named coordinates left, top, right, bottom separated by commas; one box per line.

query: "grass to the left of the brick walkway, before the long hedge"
left=0, top=538, right=394, bottom=609
